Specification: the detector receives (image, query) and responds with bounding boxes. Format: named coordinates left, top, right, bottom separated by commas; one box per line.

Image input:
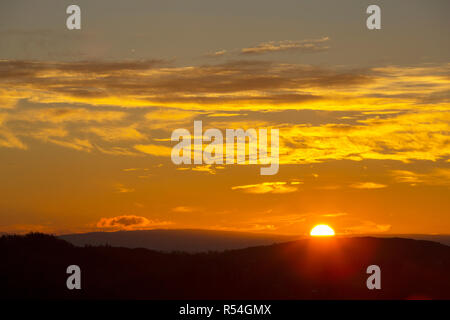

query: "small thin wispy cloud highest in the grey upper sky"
left=241, top=37, right=330, bottom=54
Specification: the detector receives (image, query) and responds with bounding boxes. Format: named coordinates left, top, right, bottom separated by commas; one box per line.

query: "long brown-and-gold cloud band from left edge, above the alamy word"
left=0, top=60, right=370, bottom=108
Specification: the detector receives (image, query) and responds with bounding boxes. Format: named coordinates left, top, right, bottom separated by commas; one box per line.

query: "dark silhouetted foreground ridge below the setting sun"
left=0, top=234, right=450, bottom=299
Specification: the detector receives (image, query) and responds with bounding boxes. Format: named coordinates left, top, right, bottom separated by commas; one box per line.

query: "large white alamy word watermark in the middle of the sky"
left=171, top=120, right=280, bottom=175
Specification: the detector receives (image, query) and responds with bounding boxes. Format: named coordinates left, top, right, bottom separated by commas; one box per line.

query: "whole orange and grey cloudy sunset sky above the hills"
left=0, top=0, right=450, bottom=235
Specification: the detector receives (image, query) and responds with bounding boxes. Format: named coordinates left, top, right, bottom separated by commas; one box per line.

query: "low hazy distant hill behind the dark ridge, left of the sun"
left=59, top=229, right=299, bottom=252
